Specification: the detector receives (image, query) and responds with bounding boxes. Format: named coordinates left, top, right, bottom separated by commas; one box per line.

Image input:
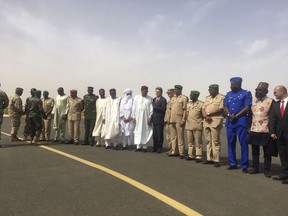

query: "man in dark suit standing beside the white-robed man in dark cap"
left=152, top=87, right=167, bottom=153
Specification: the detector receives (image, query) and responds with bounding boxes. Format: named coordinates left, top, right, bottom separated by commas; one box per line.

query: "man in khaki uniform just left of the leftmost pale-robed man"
left=40, top=91, right=54, bottom=141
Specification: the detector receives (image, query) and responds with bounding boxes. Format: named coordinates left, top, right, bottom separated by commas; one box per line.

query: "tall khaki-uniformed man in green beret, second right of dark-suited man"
left=169, top=85, right=187, bottom=159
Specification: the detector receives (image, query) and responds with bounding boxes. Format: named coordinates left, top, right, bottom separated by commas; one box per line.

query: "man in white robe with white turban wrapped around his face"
left=120, top=88, right=135, bottom=150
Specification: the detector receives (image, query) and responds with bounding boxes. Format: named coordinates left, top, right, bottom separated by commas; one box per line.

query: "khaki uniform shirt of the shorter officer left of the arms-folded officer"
left=185, top=100, right=204, bottom=130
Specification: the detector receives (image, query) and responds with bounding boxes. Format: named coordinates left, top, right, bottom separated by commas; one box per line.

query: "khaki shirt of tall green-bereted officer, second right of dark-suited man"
left=170, top=95, right=187, bottom=123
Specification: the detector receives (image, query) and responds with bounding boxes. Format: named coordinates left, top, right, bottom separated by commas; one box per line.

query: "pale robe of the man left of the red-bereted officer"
left=52, top=95, right=69, bottom=129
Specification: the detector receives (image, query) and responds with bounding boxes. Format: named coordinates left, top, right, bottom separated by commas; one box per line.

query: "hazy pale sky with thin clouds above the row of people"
left=0, top=0, right=288, bottom=99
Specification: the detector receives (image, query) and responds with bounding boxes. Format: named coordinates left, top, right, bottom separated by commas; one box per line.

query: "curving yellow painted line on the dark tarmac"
left=2, top=132, right=201, bottom=216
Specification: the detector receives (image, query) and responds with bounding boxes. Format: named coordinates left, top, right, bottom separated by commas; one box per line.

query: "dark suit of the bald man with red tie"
left=269, top=101, right=288, bottom=179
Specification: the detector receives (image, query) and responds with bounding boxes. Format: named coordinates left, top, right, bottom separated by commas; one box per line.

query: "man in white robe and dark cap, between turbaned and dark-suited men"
left=132, top=86, right=153, bottom=152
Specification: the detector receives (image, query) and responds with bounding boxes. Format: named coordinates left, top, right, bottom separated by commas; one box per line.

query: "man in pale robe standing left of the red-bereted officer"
left=52, top=87, right=68, bottom=143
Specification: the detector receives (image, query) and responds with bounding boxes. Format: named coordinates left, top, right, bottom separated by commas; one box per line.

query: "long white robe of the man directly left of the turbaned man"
left=101, top=97, right=121, bottom=139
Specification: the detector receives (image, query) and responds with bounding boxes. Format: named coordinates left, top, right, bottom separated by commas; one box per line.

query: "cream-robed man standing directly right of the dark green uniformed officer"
left=92, top=89, right=107, bottom=147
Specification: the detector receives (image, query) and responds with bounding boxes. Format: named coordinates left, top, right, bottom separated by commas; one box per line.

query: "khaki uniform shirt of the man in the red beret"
left=67, top=97, right=84, bottom=121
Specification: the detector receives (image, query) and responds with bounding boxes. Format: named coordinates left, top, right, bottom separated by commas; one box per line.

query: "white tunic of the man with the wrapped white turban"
left=120, top=97, right=135, bottom=136
